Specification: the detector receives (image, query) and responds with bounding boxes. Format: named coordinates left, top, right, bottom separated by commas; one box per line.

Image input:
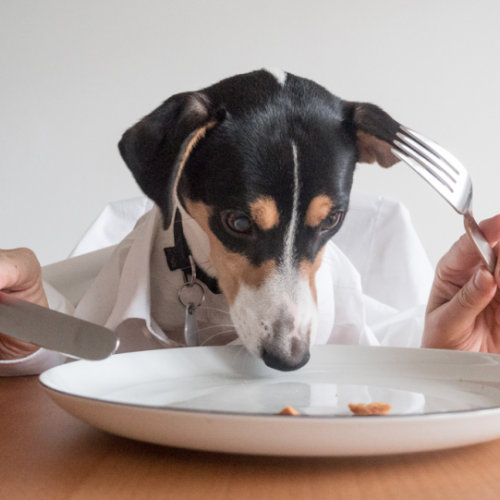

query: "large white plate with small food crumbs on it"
left=40, top=345, right=500, bottom=456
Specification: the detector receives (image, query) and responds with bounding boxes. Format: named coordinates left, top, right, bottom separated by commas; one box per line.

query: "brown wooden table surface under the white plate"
left=0, top=377, right=500, bottom=500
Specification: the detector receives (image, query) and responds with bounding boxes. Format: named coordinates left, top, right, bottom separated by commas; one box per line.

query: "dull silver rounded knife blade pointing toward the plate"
left=0, top=292, right=120, bottom=361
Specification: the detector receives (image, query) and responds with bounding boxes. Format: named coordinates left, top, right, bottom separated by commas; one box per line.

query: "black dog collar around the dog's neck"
left=163, top=209, right=222, bottom=294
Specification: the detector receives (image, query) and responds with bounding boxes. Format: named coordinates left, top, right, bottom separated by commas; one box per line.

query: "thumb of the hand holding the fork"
left=448, top=268, right=496, bottom=330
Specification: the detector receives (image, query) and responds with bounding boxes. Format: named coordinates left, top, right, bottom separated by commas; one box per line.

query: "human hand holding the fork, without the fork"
left=422, top=215, right=500, bottom=354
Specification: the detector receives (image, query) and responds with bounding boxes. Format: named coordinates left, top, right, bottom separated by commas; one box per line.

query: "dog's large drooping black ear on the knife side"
left=118, top=92, right=222, bottom=229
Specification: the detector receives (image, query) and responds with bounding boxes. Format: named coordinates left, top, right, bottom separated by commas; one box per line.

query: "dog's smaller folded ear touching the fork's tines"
left=345, top=102, right=400, bottom=168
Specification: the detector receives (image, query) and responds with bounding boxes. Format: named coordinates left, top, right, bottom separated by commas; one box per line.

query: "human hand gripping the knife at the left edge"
left=0, top=248, right=49, bottom=360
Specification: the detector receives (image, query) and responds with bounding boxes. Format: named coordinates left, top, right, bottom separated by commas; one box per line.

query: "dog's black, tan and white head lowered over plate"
left=119, top=70, right=399, bottom=370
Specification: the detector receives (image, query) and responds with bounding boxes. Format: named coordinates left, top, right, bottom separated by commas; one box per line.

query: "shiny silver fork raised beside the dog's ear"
left=392, top=126, right=497, bottom=273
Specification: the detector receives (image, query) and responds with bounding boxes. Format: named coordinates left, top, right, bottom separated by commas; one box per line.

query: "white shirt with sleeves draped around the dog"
left=0, top=192, right=433, bottom=376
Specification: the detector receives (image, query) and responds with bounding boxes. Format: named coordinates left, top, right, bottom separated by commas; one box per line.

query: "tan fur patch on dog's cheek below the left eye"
left=185, top=200, right=277, bottom=305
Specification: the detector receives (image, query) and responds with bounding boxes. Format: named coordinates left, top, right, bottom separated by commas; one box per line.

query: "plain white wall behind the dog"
left=0, top=0, right=500, bottom=264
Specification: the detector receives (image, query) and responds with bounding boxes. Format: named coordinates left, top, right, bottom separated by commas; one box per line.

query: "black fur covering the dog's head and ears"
left=119, top=71, right=399, bottom=265
